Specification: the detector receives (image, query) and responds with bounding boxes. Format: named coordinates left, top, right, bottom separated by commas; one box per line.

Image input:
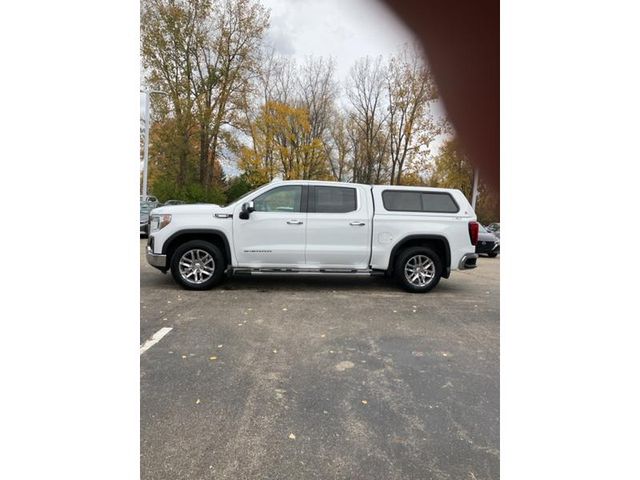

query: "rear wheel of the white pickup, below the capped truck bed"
left=394, top=247, right=442, bottom=293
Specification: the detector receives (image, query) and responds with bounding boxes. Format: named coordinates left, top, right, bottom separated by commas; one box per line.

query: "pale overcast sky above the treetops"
left=262, top=0, right=413, bottom=80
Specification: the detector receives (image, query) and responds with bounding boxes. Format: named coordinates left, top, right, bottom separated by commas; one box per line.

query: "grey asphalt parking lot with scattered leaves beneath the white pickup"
left=140, top=239, right=500, bottom=480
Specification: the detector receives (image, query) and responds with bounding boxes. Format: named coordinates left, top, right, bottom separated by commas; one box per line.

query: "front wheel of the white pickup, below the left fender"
left=171, top=240, right=226, bottom=290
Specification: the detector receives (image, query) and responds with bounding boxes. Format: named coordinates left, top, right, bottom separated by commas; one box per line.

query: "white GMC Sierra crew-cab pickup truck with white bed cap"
left=147, top=180, right=478, bottom=292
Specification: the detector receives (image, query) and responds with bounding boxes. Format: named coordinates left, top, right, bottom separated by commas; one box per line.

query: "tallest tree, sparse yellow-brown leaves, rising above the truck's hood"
left=141, top=0, right=268, bottom=196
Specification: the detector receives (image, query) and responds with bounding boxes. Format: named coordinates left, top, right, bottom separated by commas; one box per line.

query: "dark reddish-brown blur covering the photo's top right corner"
left=384, top=0, right=500, bottom=198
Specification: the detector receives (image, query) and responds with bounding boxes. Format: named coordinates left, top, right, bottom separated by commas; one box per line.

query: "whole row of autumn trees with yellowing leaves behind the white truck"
left=141, top=0, right=499, bottom=221
